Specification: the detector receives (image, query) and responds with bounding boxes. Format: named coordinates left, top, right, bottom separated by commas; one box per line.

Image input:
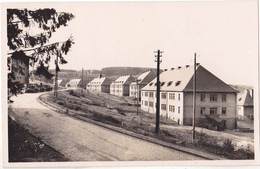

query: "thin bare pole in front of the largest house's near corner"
left=192, top=53, right=197, bottom=143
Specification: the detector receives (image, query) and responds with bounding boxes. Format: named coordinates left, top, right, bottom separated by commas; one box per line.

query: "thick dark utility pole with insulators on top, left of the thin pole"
left=155, top=50, right=163, bottom=134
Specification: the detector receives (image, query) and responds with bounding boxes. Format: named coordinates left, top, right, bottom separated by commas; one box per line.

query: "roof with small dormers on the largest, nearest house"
left=142, top=65, right=236, bottom=92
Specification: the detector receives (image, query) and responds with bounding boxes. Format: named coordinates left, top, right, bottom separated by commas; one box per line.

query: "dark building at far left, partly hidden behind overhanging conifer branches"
left=11, top=51, right=29, bottom=85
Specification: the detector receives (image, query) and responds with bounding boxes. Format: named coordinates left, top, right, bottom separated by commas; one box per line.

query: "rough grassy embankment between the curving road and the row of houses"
left=40, top=90, right=254, bottom=159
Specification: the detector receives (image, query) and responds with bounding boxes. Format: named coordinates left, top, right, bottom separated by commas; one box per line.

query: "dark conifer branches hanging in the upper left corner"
left=7, top=9, right=74, bottom=97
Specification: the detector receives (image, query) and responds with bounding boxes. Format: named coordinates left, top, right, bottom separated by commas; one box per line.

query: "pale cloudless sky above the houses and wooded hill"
left=1, top=1, right=258, bottom=86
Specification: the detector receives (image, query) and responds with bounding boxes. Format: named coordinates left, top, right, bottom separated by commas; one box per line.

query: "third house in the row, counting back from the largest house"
left=110, top=75, right=135, bottom=96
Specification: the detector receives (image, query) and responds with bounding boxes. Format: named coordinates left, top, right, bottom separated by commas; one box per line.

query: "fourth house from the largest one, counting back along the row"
left=86, top=76, right=112, bottom=93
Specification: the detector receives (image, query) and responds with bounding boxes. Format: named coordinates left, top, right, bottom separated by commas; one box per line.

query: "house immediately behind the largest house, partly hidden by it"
left=129, top=70, right=156, bottom=98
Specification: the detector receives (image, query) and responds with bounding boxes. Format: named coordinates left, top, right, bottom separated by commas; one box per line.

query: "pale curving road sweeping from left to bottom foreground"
left=9, top=93, right=204, bottom=161
